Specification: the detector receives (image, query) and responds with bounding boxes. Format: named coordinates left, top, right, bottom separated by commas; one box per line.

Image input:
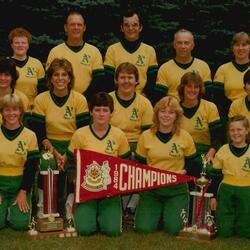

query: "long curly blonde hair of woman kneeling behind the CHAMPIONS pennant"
left=151, top=96, right=183, bottom=134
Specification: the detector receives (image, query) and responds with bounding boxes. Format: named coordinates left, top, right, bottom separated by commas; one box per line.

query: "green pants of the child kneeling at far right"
left=216, top=183, right=250, bottom=237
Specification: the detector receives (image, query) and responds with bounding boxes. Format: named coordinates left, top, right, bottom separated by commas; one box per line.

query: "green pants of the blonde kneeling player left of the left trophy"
left=0, top=176, right=31, bottom=231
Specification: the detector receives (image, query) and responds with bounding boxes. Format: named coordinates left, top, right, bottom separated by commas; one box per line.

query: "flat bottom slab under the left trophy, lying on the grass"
left=28, top=230, right=78, bottom=240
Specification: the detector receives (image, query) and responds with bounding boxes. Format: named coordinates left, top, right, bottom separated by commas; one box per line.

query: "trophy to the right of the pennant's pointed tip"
left=178, top=155, right=216, bottom=241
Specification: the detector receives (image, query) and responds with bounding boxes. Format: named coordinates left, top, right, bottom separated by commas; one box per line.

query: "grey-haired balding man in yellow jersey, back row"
left=154, top=29, right=212, bottom=102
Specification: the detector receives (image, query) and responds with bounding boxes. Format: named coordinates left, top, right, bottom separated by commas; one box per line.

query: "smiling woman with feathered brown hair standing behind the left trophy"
left=32, top=59, right=89, bottom=215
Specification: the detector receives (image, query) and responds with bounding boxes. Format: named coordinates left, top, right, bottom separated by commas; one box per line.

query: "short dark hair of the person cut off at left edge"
left=0, top=57, right=19, bottom=90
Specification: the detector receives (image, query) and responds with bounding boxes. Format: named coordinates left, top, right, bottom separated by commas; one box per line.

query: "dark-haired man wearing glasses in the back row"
left=104, top=10, right=158, bottom=99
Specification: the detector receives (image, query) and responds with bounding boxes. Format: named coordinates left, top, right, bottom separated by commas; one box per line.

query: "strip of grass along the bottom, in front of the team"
left=0, top=226, right=250, bottom=250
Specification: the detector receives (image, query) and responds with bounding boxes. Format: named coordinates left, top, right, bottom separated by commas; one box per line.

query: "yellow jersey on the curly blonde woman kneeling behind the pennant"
left=136, top=129, right=196, bottom=172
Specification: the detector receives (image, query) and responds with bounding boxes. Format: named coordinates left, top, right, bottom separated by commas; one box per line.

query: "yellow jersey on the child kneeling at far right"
left=213, top=144, right=250, bottom=186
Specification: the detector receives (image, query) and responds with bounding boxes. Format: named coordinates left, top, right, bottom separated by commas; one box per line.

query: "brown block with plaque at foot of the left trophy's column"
left=36, top=217, right=64, bottom=232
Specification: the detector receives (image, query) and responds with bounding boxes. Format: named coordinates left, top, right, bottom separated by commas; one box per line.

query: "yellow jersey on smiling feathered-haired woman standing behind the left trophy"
left=32, top=90, right=89, bottom=141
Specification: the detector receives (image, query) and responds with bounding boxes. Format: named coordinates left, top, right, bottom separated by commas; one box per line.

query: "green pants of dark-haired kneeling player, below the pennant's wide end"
left=74, top=196, right=122, bottom=236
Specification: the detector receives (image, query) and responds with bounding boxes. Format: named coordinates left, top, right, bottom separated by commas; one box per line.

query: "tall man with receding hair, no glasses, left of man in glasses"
left=46, top=11, right=104, bottom=99
